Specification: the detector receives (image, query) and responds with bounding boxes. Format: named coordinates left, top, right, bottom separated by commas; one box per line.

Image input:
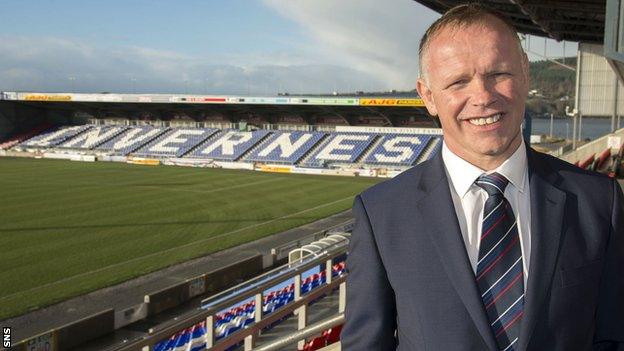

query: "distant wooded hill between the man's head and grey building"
left=527, top=57, right=576, bottom=117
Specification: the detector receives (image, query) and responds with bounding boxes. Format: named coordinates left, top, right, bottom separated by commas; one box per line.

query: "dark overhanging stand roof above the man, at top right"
left=415, top=0, right=606, bottom=44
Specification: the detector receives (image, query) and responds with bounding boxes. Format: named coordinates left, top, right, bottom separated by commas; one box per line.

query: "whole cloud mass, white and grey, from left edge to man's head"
left=0, top=0, right=438, bottom=95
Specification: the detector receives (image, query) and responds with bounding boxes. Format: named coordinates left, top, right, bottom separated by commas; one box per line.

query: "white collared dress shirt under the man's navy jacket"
left=442, top=141, right=531, bottom=291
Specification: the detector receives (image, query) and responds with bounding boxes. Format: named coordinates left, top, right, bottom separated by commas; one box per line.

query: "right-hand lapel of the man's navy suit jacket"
left=518, top=148, right=566, bottom=350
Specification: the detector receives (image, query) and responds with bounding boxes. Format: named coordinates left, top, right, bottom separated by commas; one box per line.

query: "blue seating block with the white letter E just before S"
left=305, top=133, right=377, bottom=167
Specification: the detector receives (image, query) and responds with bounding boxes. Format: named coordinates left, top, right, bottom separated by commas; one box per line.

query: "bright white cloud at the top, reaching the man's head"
left=264, top=0, right=439, bottom=90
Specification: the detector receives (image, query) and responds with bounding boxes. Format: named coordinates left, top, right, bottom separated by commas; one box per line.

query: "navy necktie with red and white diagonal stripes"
left=475, top=173, right=524, bottom=351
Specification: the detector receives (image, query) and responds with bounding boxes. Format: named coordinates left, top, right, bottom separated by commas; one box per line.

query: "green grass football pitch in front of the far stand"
left=0, top=157, right=379, bottom=320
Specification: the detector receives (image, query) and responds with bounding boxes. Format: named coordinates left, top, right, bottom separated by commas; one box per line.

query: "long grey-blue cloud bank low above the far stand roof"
left=0, top=35, right=381, bottom=95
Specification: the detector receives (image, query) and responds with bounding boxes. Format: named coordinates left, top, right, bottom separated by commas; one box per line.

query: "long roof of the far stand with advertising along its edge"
left=0, top=92, right=439, bottom=127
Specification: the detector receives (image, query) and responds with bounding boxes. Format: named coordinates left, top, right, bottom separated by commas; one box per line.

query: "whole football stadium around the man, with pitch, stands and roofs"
left=0, top=0, right=624, bottom=351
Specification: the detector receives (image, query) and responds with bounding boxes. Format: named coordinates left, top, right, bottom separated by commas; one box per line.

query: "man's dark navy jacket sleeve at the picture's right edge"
left=594, top=180, right=624, bottom=351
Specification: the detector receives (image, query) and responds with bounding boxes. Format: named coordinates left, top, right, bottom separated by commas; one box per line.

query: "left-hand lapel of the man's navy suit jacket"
left=415, top=152, right=497, bottom=350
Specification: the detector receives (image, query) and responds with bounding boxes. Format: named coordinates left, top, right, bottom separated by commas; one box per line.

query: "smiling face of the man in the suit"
left=416, top=16, right=528, bottom=170
